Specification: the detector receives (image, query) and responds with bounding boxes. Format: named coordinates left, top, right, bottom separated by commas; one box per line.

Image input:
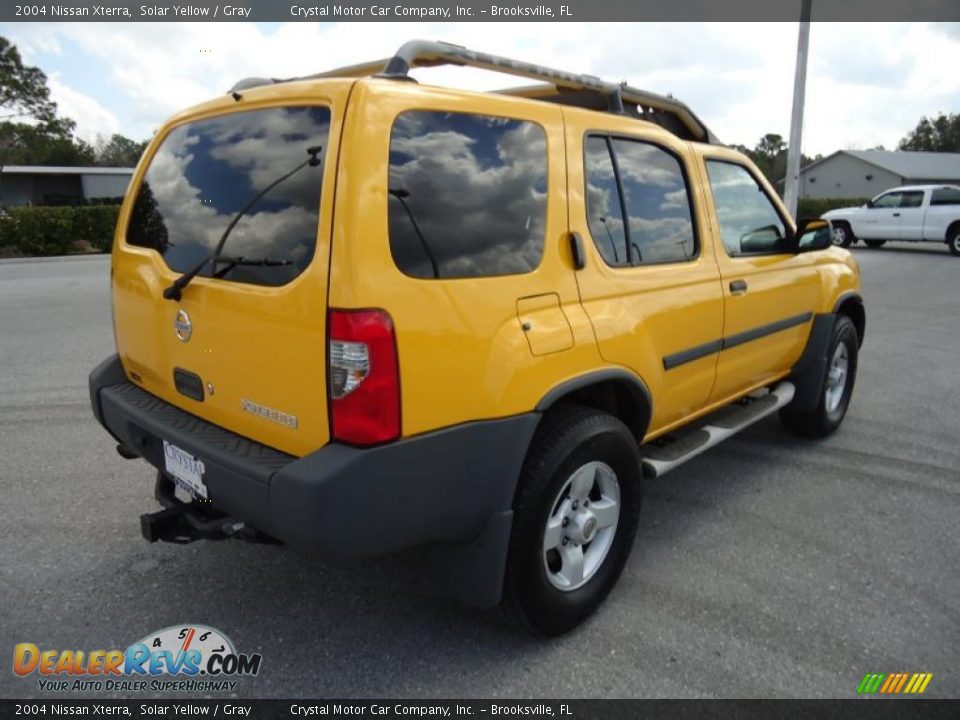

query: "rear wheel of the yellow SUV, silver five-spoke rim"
left=501, top=406, right=642, bottom=635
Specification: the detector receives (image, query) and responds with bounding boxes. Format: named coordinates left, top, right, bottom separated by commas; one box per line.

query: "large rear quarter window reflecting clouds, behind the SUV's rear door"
left=388, top=110, right=547, bottom=278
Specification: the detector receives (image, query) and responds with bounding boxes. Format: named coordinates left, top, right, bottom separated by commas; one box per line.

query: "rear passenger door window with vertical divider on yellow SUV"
left=584, top=135, right=697, bottom=267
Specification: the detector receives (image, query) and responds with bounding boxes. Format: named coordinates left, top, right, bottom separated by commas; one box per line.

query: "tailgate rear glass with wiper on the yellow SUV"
left=127, top=107, right=330, bottom=286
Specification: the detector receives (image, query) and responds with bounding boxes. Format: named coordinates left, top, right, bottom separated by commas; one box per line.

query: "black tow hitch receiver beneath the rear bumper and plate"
left=140, top=472, right=276, bottom=544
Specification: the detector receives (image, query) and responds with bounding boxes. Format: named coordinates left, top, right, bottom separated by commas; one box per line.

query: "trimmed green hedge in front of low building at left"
left=0, top=205, right=120, bottom=256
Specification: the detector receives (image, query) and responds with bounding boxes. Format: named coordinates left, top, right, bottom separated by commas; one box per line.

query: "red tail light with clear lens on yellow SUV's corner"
left=327, top=310, right=400, bottom=445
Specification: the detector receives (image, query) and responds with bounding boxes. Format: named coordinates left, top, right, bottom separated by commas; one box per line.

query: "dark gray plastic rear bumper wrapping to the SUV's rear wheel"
left=90, top=356, right=540, bottom=606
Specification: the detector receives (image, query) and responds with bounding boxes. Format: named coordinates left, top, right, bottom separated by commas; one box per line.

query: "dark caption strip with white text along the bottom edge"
left=0, top=697, right=960, bottom=720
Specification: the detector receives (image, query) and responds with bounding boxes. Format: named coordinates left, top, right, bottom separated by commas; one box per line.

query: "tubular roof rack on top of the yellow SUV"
left=230, top=40, right=719, bottom=143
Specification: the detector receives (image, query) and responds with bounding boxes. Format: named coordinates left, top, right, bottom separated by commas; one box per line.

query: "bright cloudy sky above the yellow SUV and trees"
left=0, top=22, right=960, bottom=155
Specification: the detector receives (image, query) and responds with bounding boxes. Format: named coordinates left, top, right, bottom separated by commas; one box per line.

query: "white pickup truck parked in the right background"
left=823, top=185, right=960, bottom=255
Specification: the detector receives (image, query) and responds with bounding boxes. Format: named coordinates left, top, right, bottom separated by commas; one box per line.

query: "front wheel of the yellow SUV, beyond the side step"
left=780, top=315, right=859, bottom=437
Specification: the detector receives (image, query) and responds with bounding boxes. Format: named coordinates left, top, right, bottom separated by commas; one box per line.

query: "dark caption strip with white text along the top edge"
left=0, top=0, right=960, bottom=22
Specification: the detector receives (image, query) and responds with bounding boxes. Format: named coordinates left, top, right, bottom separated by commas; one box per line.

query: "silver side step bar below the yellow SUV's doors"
left=642, top=382, right=796, bottom=478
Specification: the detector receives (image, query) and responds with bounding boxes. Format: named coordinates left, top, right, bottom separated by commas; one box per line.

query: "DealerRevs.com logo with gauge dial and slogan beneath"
left=13, top=625, right=262, bottom=692
